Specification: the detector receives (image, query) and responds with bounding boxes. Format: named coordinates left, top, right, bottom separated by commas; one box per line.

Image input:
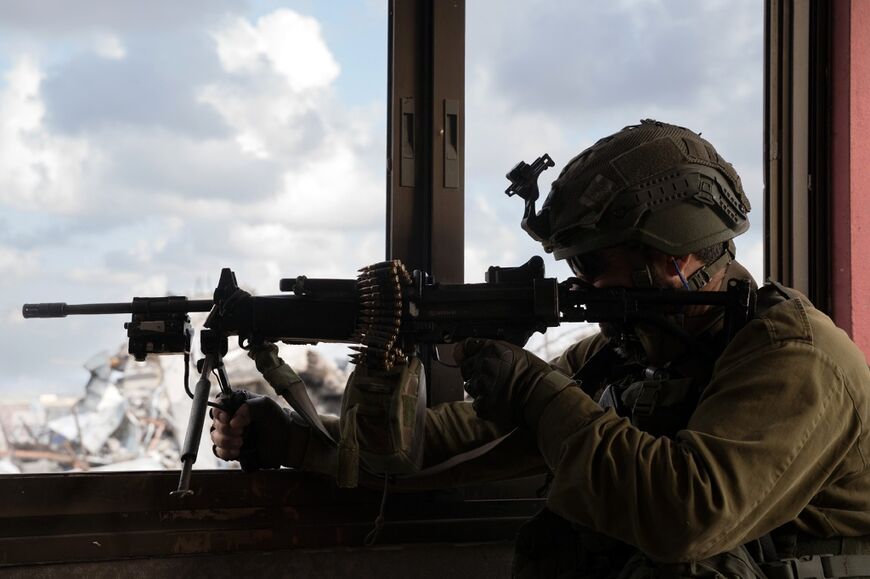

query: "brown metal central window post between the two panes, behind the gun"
left=386, top=0, right=465, bottom=404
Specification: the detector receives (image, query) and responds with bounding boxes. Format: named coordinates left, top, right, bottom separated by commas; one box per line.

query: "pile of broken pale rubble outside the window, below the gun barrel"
left=0, top=345, right=348, bottom=474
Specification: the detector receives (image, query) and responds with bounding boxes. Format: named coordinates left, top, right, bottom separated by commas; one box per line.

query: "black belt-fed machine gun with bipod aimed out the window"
left=22, top=256, right=756, bottom=496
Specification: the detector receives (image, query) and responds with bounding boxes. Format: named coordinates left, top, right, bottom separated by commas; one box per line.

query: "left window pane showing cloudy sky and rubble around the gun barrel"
left=0, top=0, right=387, bottom=472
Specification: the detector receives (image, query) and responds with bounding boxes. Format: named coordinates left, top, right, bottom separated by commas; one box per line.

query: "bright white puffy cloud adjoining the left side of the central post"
left=201, top=10, right=385, bottom=231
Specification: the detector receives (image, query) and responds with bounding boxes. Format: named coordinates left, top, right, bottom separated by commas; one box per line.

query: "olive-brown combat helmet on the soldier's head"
left=523, top=119, right=750, bottom=288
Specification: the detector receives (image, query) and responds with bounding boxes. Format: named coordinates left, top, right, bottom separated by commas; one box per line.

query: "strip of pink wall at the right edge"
left=831, top=0, right=870, bottom=358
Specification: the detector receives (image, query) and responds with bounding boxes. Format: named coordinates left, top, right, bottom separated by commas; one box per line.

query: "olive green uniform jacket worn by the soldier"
left=406, top=266, right=870, bottom=562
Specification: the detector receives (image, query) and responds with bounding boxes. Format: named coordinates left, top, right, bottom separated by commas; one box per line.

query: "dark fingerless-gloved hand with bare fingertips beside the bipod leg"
left=211, top=396, right=310, bottom=471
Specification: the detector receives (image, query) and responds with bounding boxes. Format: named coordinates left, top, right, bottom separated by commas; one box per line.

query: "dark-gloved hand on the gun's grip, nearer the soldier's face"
left=453, top=338, right=553, bottom=428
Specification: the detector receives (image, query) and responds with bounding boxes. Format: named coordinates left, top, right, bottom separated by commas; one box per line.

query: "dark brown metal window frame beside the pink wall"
left=764, top=0, right=833, bottom=312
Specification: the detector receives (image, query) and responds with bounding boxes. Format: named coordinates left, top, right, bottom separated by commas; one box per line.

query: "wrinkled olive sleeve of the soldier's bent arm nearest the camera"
left=538, top=300, right=861, bottom=562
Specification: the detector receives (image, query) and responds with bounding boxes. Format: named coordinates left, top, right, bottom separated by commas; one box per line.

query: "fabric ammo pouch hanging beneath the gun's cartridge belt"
left=337, top=358, right=426, bottom=487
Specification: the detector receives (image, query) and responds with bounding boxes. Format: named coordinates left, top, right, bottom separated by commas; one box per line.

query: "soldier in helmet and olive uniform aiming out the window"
left=212, top=121, right=870, bottom=578
